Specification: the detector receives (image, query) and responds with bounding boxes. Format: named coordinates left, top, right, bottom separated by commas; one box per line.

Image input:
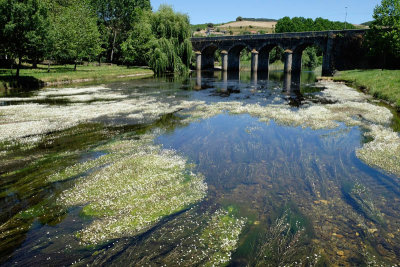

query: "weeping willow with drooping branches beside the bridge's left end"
left=122, top=5, right=192, bottom=75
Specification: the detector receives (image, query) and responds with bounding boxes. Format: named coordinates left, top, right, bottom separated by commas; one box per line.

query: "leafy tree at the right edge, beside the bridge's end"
left=367, top=0, right=400, bottom=67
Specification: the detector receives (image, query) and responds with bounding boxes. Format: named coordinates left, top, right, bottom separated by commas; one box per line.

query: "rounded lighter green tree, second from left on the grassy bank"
left=50, top=2, right=101, bottom=70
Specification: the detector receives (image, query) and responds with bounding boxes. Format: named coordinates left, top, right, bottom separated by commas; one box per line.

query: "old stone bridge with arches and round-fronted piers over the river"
left=191, top=30, right=367, bottom=76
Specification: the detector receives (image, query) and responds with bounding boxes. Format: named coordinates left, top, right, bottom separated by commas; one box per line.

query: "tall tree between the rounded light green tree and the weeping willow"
left=91, top=0, right=151, bottom=62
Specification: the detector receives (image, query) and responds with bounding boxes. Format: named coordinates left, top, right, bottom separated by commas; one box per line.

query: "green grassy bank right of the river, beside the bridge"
left=334, top=70, right=400, bottom=111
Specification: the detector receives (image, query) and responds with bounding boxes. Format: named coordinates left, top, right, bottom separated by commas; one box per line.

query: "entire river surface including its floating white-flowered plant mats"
left=0, top=72, right=400, bottom=266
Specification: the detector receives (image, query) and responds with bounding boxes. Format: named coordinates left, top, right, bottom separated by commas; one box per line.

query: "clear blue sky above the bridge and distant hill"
left=151, top=0, right=381, bottom=24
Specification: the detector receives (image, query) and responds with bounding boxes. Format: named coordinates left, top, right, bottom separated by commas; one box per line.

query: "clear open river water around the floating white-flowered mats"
left=0, top=72, right=400, bottom=266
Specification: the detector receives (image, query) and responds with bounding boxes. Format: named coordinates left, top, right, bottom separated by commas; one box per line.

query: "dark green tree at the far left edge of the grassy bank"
left=0, top=0, right=49, bottom=77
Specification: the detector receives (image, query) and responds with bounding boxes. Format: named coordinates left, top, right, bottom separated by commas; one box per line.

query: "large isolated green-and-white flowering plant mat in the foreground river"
left=58, top=137, right=207, bottom=244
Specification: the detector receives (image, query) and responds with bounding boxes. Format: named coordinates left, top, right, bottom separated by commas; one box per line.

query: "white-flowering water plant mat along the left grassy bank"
left=0, top=87, right=199, bottom=142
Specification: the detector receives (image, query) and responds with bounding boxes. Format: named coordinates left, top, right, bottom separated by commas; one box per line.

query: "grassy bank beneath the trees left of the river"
left=0, top=65, right=153, bottom=89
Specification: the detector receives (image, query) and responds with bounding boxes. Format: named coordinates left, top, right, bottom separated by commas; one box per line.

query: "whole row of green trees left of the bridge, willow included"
left=0, top=0, right=192, bottom=76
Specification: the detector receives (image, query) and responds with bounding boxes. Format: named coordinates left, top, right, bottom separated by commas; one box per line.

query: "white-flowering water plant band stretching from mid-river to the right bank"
left=181, top=82, right=400, bottom=176
